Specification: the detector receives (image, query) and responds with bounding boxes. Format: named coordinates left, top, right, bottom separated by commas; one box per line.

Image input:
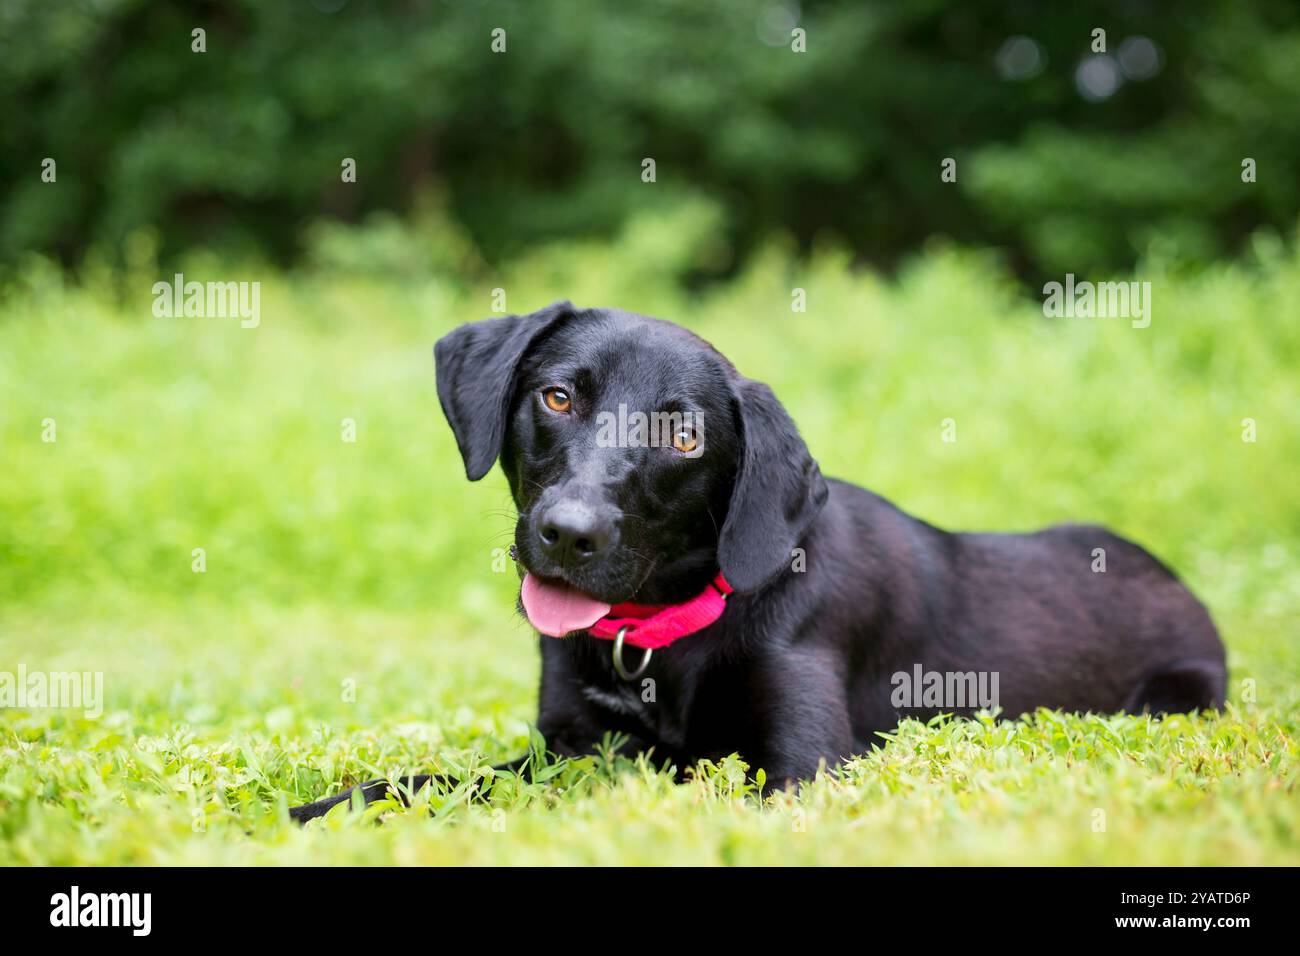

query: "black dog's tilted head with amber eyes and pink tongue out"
left=434, top=302, right=827, bottom=633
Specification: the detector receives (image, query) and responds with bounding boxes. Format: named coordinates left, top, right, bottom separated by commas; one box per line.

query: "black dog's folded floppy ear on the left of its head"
left=433, top=302, right=575, bottom=481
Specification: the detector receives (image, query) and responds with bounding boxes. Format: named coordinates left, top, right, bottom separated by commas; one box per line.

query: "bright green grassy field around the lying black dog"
left=0, top=210, right=1300, bottom=865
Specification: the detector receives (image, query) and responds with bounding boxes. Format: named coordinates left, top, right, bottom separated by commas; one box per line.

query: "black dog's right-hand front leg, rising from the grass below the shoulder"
left=748, top=644, right=853, bottom=790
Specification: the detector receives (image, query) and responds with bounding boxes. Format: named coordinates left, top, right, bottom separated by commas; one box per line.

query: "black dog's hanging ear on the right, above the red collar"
left=718, top=380, right=827, bottom=592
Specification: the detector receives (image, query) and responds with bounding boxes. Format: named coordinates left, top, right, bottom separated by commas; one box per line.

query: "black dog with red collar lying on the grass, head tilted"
left=293, top=302, right=1226, bottom=819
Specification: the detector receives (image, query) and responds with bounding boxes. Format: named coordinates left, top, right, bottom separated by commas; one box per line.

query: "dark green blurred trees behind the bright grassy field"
left=0, top=0, right=1300, bottom=278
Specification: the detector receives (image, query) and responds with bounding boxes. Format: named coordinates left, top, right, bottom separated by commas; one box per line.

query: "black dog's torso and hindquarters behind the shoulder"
left=820, top=481, right=1227, bottom=730
